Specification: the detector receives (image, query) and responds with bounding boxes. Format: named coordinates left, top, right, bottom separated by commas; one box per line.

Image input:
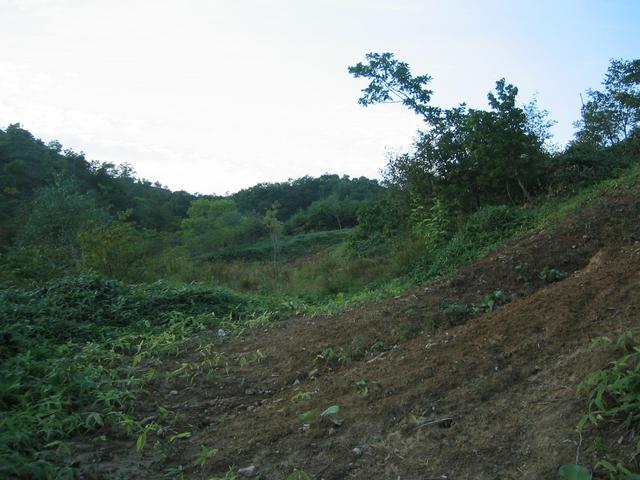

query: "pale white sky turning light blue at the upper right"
left=0, top=0, right=640, bottom=195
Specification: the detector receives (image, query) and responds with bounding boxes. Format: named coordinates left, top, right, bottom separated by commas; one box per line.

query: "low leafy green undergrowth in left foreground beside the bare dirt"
left=0, top=275, right=280, bottom=478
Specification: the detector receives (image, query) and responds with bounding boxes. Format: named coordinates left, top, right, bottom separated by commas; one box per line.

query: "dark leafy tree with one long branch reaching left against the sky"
left=349, top=53, right=549, bottom=210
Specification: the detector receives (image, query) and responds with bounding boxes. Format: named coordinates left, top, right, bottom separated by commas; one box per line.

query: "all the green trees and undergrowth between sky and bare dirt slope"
left=0, top=53, right=640, bottom=478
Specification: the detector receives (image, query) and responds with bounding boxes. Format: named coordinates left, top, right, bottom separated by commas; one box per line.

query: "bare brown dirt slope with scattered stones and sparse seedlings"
left=72, top=191, right=640, bottom=480
